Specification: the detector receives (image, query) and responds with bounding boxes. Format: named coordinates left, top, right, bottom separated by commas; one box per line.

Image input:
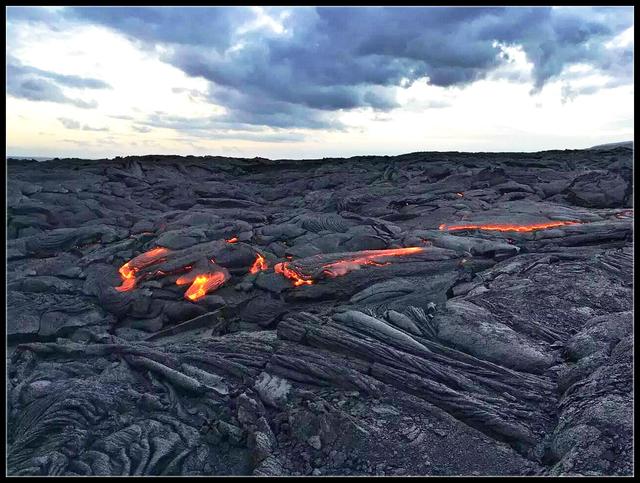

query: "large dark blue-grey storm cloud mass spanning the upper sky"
left=7, top=7, right=633, bottom=128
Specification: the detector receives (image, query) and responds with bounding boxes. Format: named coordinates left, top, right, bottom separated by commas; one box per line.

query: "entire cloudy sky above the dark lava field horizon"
left=6, top=7, right=634, bottom=159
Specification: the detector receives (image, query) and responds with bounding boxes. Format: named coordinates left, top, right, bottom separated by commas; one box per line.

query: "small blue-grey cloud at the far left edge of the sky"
left=7, top=57, right=110, bottom=109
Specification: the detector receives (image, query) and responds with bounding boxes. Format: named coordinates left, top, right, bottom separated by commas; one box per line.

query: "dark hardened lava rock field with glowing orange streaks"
left=7, top=147, right=633, bottom=475
